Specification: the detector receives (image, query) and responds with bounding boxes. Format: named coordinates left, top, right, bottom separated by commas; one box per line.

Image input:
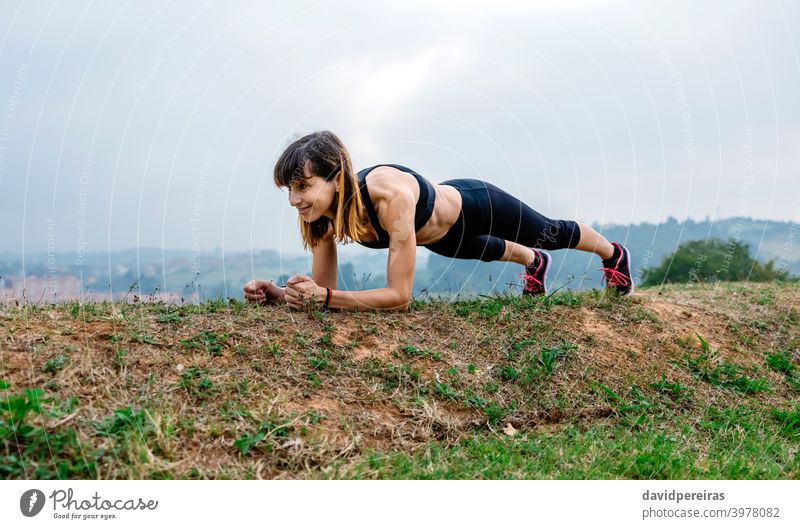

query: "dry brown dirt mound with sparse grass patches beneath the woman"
left=0, top=284, right=800, bottom=477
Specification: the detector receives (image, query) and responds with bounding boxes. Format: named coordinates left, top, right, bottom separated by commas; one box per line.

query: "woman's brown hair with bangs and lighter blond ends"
left=273, top=130, right=369, bottom=250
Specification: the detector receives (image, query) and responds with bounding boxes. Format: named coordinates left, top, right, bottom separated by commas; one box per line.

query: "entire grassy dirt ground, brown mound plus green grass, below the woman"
left=0, top=283, right=800, bottom=479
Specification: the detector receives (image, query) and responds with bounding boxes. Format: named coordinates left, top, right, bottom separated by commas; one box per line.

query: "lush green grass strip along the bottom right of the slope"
left=323, top=408, right=800, bottom=479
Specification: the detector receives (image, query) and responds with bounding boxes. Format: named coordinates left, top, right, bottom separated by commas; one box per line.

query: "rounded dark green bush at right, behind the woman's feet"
left=642, top=238, right=790, bottom=286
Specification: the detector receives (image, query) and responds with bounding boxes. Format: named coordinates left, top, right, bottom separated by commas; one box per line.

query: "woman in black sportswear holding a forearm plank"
left=244, top=131, right=634, bottom=311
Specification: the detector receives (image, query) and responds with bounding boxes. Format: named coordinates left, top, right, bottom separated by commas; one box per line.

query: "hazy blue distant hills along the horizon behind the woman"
left=0, top=218, right=800, bottom=299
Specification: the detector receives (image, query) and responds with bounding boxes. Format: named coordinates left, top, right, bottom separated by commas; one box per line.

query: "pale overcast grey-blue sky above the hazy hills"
left=0, top=0, right=800, bottom=262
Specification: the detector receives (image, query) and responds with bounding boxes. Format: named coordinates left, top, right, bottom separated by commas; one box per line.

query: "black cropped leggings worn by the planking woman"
left=424, top=178, right=581, bottom=261
